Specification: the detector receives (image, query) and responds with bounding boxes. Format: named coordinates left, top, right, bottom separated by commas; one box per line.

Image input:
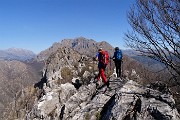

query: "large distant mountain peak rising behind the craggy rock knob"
left=37, top=37, right=114, bottom=61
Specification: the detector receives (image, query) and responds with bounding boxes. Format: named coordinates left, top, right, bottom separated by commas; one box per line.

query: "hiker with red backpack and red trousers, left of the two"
left=96, top=48, right=109, bottom=88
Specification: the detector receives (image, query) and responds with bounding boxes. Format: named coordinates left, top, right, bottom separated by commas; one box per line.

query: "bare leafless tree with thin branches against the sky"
left=125, top=0, right=180, bottom=83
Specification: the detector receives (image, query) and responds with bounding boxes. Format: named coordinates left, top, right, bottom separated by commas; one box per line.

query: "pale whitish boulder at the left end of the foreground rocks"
left=27, top=83, right=76, bottom=119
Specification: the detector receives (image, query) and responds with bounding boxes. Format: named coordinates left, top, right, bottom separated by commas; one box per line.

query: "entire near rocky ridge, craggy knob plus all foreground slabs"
left=3, top=47, right=180, bottom=120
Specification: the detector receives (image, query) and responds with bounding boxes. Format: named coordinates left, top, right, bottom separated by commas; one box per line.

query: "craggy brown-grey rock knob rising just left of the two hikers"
left=35, top=47, right=94, bottom=88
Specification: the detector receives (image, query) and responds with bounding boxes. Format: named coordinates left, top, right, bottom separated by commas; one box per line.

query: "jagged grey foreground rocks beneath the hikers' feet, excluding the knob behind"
left=26, top=78, right=180, bottom=120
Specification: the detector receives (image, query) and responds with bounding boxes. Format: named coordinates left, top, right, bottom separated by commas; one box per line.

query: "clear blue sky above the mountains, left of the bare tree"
left=0, top=0, right=134, bottom=53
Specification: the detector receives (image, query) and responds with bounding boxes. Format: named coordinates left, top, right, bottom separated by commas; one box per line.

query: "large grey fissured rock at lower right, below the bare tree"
left=110, top=80, right=180, bottom=120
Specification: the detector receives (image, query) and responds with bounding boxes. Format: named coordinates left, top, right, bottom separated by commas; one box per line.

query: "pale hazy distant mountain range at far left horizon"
left=0, top=48, right=36, bottom=61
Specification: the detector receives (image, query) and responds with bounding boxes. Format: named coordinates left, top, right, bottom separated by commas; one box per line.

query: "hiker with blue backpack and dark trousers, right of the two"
left=112, top=47, right=122, bottom=77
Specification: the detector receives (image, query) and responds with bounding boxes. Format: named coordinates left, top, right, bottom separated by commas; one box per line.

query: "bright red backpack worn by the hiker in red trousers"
left=99, top=51, right=109, bottom=65
